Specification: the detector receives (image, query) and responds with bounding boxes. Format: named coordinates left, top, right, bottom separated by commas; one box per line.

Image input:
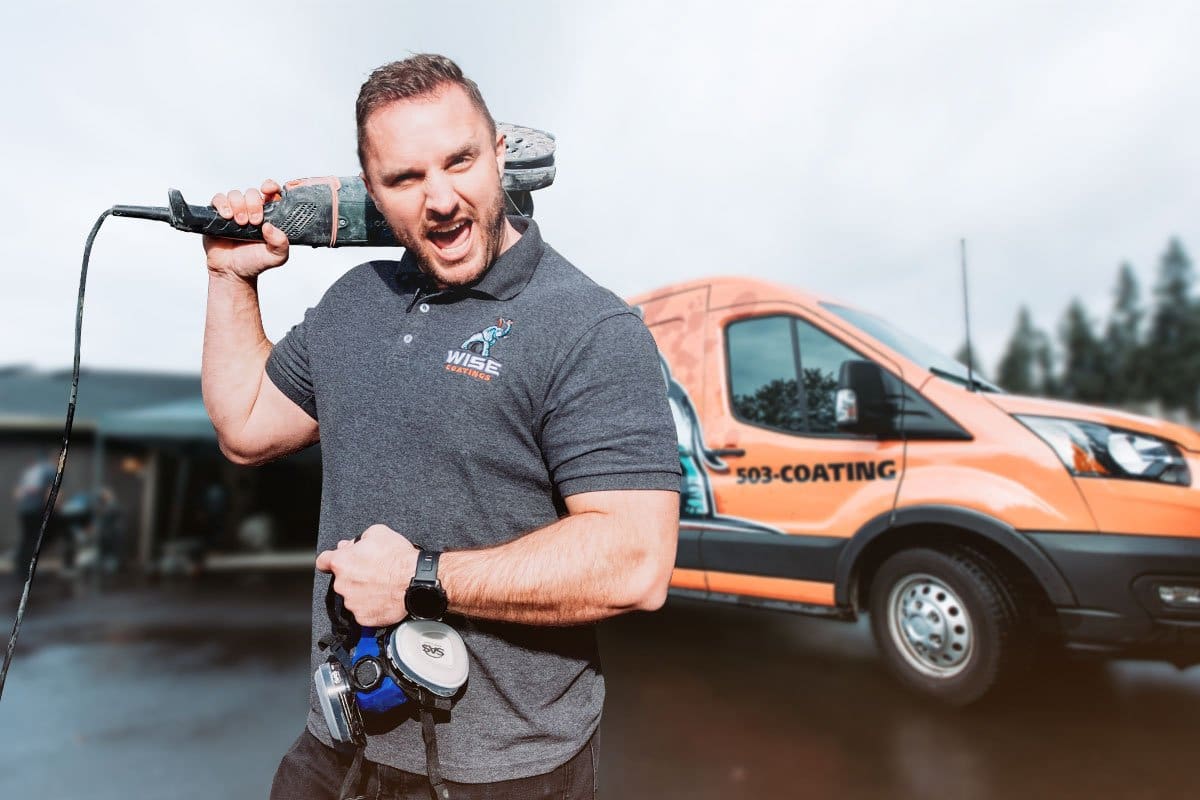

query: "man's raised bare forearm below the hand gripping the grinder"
left=200, top=273, right=271, bottom=448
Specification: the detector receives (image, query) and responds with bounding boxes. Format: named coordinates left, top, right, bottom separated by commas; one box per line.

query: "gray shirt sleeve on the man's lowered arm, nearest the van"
left=540, top=311, right=679, bottom=498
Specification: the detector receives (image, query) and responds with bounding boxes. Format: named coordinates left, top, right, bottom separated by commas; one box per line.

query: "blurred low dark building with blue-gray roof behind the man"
left=0, top=367, right=320, bottom=571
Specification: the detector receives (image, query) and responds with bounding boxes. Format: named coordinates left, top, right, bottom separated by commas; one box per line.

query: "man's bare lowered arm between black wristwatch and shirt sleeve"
left=439, top=493, right=678, bottom=625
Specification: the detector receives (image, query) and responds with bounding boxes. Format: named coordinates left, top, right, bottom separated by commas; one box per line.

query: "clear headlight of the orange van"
left=1016, top=415, right=1192, bottom=486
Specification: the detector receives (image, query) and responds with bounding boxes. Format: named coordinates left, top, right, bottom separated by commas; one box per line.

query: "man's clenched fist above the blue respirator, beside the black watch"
left=317, top=525, right=418, bottom=627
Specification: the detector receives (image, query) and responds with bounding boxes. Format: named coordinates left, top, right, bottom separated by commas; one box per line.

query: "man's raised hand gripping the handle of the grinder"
left=204, top=179, right=289, bottom=281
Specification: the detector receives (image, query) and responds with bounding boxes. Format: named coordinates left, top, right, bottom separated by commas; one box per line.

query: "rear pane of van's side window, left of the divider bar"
left=726, top=317, right=805, bottom=433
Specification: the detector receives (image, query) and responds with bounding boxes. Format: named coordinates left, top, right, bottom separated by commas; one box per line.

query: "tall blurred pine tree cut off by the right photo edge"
left=1145, top=239, right=1200, bottom=414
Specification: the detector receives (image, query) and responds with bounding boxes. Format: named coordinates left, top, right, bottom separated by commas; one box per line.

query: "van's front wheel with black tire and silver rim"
left=869, top=547, right=1024, bottom=706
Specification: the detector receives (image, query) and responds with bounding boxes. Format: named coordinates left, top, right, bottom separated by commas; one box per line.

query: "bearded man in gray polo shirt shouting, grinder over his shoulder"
left=203, top=55, right=679, bottom=798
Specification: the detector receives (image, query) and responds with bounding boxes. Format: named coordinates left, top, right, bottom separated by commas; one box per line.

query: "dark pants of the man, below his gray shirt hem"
left=271, top=728, right=600, bottom=800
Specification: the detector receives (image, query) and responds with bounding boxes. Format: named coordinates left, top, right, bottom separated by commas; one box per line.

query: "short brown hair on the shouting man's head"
left=354, top=53, right=496, bottom=169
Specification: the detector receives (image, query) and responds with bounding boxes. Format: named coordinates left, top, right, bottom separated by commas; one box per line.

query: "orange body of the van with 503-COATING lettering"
left=631, top=277, right=1200, bottom=606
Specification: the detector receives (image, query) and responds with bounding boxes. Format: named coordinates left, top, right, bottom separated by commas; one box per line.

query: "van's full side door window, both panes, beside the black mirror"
left=725, top=317, right=863, bottom=434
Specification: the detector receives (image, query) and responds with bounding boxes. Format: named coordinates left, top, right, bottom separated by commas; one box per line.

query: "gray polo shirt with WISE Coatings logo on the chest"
left=266, top=217, right=679, bottom=783
